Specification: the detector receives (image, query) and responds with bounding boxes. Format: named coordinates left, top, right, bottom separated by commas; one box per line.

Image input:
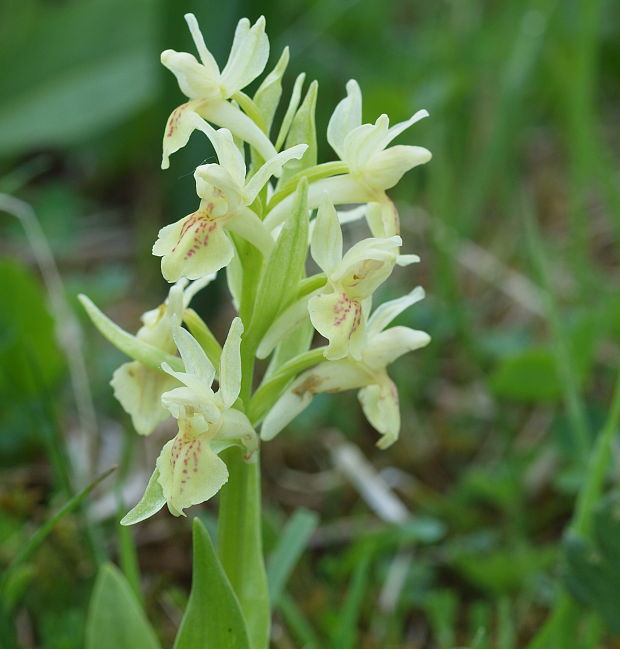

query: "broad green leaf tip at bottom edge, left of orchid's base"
left=85, top=563, right=160, bottom=649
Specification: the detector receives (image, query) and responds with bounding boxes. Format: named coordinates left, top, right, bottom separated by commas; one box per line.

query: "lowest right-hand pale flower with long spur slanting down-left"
left=261, top=287, right=430, bottom=448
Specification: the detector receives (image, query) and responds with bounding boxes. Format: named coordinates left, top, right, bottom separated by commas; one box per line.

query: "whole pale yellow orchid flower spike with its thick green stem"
left=81, top=14, right=431, bottom=649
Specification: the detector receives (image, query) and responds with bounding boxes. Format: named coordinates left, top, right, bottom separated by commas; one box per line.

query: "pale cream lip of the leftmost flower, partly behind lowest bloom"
left=110, top=361, right=178, bottom=435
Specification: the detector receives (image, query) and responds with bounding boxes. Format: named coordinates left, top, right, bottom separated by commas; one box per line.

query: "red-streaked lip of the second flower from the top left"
left=153, top=209, right=234, bottom=282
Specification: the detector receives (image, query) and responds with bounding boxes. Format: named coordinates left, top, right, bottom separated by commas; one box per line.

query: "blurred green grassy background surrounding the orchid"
left=0, top=0, right=620, bottom=649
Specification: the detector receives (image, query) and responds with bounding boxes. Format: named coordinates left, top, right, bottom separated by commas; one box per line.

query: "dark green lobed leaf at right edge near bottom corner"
left=564, top=493, right=620, bottom=634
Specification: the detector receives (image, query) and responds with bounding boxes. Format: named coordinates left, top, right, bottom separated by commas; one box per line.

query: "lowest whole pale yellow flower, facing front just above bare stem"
left=121, top=318, right=258, bottom=525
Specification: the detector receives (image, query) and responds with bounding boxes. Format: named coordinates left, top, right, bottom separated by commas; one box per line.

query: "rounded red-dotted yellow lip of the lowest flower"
left=157, top=422, right=228, bottom=516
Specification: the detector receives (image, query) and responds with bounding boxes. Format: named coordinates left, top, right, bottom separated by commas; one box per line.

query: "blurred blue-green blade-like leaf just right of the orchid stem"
left=267, top=509, right=318, bottom=607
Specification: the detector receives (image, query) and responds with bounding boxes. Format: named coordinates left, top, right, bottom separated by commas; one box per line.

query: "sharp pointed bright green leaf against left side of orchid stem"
left=174, top=518, right=250, bottom=649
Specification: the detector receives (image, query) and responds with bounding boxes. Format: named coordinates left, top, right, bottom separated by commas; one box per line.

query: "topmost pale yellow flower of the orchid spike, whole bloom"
left=161, top=14, right=276, bottom=169
